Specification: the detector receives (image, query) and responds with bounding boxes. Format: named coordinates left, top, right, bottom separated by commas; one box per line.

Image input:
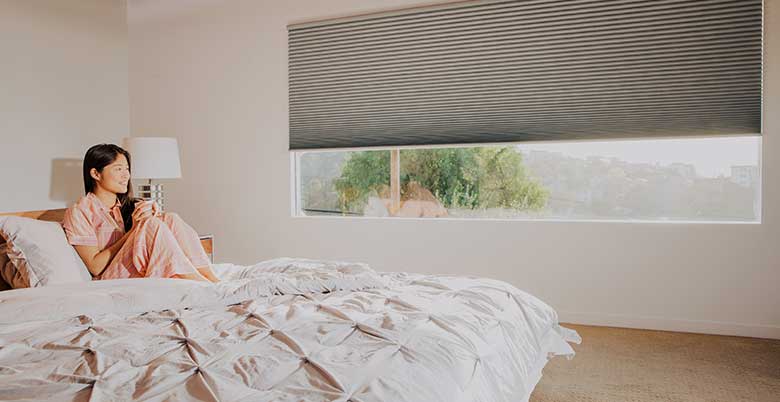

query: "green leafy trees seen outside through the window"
left=335, top=147, right=548, bottom=211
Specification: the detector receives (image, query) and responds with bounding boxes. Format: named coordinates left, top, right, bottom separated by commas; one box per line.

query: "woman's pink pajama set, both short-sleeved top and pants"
left=62, top=193, right=209, bottom=279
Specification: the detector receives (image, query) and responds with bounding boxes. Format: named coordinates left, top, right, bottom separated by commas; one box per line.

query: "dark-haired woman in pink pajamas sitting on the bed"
left=62, top=144, right=219, bottom=282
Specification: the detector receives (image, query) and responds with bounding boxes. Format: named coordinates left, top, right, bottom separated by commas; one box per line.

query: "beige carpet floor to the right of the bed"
left=531, top=324, right=780, bottom=402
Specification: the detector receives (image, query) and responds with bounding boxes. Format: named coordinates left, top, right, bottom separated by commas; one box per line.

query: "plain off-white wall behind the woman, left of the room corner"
left=0, top=0, right=129, bottom=212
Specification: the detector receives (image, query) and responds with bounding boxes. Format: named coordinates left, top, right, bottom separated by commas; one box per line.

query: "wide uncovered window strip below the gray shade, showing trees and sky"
left=295, top=137, right=761, bottom=222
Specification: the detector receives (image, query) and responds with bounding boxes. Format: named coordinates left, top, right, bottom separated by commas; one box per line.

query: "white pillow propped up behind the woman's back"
left=0, top=216, right=92, bottom=288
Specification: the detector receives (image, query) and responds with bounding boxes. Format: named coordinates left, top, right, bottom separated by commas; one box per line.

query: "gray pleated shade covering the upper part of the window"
left=288, top=0, right=762, bottom=149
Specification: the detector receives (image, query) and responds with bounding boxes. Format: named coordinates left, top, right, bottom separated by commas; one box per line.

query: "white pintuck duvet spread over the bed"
left=0, top=259, right=579, bottom=402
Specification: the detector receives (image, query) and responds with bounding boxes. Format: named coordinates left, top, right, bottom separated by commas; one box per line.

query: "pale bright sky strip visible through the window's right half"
left=518, top=137, right=761, bottom=177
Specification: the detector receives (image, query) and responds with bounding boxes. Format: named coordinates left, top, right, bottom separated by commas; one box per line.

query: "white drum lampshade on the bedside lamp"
left=122, top=137, right=181, bottom=179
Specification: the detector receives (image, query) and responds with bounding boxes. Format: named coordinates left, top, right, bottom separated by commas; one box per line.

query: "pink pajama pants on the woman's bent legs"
left=100, top=212, right=209, bottom=279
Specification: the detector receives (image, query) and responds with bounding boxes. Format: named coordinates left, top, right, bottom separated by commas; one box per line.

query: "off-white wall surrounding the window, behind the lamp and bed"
left=128, top=0, right=780, bottom=338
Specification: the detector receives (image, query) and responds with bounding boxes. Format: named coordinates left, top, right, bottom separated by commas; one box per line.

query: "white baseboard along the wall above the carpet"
left=558, top=311, right=780, bottom=339
